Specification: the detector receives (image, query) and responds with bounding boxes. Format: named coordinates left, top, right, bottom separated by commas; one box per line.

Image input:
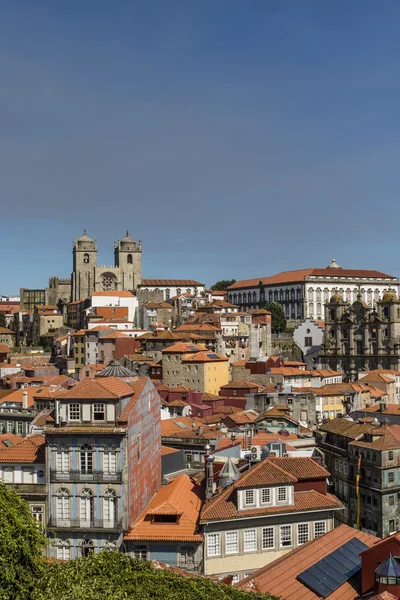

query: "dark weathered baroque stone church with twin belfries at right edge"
left=321, top=290, right=400, bottom=381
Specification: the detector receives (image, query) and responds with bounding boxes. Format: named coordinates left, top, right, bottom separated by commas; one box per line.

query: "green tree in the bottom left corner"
left=0, top=482, right=47, bottom=600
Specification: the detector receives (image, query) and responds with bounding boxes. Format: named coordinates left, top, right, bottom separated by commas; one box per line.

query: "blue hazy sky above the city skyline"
left=0, top=0, right=400, bottom=294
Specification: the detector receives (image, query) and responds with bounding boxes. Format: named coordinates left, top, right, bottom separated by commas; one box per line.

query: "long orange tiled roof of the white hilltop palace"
left=228, top=269, right=396, bottom=292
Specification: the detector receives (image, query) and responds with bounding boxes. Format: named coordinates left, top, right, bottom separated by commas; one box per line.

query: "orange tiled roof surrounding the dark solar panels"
left=235, top=525, right=379, bottom=600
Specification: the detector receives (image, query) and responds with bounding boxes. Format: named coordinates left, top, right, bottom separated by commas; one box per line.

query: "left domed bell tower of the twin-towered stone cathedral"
left=71, top=229, right=97, bottom=301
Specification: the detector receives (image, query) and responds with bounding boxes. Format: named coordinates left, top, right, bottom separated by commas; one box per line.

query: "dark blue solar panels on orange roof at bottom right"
left=297, top=538, right=368, bottom=598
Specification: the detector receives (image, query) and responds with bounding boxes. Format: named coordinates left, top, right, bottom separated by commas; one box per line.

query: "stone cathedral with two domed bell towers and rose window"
left=71, top=230, right=142, bottom=301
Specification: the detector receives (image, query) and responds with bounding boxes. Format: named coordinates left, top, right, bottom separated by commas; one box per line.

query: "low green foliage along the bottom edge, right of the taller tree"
left=32, top=550, right=278, bottom=600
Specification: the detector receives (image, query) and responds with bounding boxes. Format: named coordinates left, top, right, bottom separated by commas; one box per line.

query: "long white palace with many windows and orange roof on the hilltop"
left=228, top=259, right=400, bottom=321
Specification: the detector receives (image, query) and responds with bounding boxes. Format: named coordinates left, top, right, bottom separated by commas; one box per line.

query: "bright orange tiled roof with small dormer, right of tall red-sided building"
left=124, top=474, right=203, bottom=542
